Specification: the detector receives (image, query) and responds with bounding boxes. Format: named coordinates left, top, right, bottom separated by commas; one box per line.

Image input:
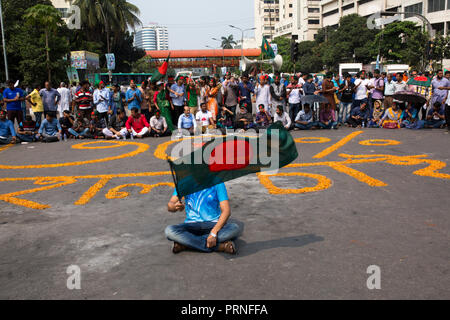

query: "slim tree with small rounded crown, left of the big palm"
left=23, top=4, right=64, bottom=81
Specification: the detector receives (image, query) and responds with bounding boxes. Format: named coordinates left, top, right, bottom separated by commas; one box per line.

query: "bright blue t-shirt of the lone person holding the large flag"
left=173, top=183, right=228, bottom=223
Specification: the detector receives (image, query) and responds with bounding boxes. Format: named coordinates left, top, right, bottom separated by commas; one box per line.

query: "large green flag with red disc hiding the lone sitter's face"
left=168, top=123, right=298, bottom=199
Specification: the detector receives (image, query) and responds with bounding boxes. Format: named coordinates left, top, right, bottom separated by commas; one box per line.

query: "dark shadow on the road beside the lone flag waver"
left=226, top=234, right=325, bottom=259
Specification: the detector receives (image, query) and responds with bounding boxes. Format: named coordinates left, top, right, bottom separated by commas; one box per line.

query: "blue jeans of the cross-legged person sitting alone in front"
left=165, top=222, right=240, bottom=252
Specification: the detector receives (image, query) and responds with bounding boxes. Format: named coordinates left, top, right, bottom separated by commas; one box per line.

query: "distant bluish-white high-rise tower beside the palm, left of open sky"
left=134, top=24, right=169, bottom=51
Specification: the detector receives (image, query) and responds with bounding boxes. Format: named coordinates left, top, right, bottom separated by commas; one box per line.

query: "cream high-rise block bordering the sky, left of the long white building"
left=275, top=0, right=321, bottom=41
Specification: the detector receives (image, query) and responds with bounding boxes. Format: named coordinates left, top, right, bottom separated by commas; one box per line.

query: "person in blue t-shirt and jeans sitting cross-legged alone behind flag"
left=165, top=183, right=240, bottom=254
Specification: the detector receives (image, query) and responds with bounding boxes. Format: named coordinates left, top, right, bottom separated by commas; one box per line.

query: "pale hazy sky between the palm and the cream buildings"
left=128, top=0, right=254, bottom=50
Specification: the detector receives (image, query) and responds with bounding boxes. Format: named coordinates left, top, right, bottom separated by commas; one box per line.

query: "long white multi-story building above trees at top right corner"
left=320, top=0, right=450, bottom=34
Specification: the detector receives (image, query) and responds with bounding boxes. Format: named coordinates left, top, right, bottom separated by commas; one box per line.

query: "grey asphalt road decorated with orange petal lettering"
left=0, top=129, right=450, bottom=299
